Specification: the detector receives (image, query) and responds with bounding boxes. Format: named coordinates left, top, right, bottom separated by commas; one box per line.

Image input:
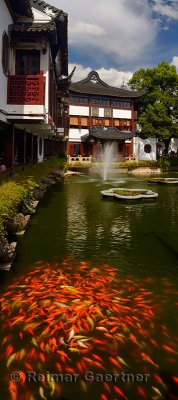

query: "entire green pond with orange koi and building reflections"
left=0, top=174, right=178, bottom=400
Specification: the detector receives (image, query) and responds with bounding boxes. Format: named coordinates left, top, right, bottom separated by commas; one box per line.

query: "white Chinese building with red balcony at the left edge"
left=0, top=0, right=68, bottom=168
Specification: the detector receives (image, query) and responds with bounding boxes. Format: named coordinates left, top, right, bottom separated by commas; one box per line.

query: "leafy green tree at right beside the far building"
left=129, top=61, right=178, bottom=154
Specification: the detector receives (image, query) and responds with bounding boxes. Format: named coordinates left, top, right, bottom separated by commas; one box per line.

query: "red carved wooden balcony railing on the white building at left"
left=7, top=75, right=45, bottom=105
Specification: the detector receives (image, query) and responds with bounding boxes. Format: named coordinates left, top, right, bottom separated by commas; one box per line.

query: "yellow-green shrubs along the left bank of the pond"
left=0, top=157, right=64, bottom=268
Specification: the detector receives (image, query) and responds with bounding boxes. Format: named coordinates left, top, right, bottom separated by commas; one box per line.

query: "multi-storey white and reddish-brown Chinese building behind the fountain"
left=67, top=71, right=147, bottom=161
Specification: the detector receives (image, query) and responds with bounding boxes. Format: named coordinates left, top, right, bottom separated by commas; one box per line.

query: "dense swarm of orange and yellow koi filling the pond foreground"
left=0, top=259, right=178, bottom=400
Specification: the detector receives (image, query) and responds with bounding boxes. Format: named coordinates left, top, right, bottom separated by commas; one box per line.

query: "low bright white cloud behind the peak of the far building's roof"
left=69, top=64, right=133, bottom=87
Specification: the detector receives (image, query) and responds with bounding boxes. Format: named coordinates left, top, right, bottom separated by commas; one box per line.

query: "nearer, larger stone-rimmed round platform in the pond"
left=101, top=188, right=158, bottom=202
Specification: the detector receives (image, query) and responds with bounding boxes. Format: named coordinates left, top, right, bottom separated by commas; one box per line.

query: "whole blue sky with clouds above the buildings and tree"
left=47, top=0, right=178, bottom=87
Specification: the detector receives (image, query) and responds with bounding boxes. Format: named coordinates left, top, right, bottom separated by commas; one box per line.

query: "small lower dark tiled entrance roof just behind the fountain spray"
left=89, top=126, right=134, bottom=140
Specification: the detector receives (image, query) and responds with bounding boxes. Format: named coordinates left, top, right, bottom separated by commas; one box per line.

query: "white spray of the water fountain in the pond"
left=96, top=142, right=118, bottom=182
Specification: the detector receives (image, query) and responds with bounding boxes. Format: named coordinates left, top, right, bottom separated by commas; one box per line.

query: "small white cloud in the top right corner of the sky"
left=153, top=0, right=178, bottom=20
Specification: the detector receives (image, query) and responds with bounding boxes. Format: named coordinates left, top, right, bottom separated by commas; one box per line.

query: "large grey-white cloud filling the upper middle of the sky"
left=49, top=0, right=159, bottom=65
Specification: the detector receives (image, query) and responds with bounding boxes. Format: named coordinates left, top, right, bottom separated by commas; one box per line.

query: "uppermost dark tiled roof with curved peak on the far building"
left=69, top=71, right=146, bottom=98
